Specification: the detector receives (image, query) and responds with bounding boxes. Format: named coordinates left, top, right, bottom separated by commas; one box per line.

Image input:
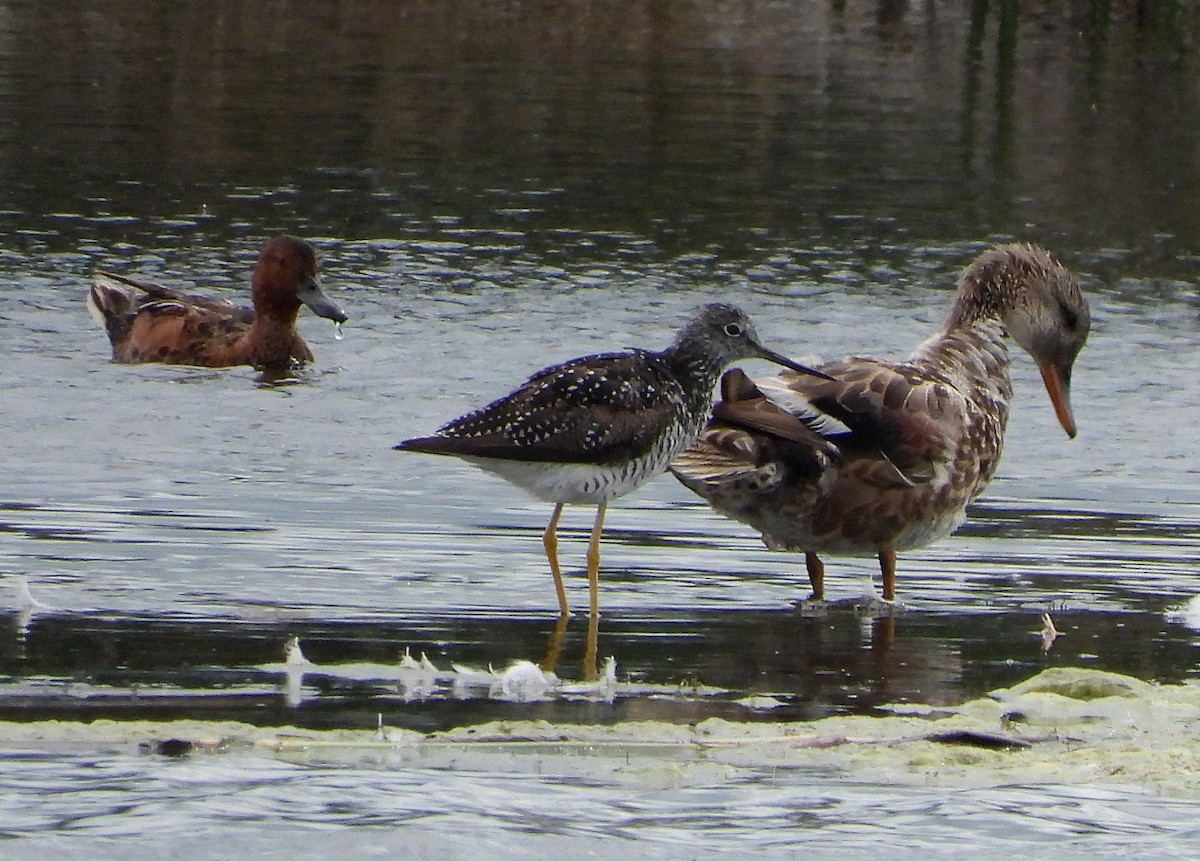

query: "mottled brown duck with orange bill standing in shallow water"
left=671, top=245, right=1091, bottom=602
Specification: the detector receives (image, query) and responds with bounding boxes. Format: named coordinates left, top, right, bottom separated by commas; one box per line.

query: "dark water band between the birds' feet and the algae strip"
left=0, top=597, right=1200, bottom=730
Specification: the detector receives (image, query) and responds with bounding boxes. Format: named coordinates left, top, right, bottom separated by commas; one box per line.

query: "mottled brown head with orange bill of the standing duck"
left=952, top=245, right=1092, bottom=438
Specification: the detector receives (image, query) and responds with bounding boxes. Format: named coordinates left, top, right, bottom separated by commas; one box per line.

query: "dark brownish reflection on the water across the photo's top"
left=0, top=0, right=1200, bottom=254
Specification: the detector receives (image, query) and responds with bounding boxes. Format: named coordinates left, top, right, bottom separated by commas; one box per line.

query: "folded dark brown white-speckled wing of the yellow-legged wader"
left=396, top=350, right=683, bottom=463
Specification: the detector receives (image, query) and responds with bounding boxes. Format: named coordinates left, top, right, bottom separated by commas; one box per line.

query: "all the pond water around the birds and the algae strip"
left=0, top=0, right=1200, bottom=856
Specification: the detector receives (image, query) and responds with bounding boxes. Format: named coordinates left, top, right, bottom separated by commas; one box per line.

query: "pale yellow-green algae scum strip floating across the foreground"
left=0, top=668, right=1200, bottom=797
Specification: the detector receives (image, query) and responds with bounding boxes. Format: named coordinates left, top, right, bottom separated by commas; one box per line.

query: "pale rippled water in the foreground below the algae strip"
left=2, top=755, right=1196, bottom=859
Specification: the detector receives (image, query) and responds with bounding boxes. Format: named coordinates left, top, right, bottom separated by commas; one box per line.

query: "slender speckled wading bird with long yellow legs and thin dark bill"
left=395, top=303, right=823, bottom=619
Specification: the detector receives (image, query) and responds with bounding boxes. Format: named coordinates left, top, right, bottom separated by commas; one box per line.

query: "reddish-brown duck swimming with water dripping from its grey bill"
left=88, top=235, right=347, bottom=369
